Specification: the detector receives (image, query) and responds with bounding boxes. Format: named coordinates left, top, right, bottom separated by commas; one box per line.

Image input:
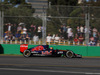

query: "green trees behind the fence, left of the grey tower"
left=0, top=0, right=42, bottom=28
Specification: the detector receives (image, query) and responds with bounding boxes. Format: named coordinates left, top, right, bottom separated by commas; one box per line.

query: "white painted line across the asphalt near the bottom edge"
left=0, top=68, right=100, bottom=75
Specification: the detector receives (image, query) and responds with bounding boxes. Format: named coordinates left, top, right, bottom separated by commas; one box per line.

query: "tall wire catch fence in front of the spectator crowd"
left=0, top=5, right=100, bottom=46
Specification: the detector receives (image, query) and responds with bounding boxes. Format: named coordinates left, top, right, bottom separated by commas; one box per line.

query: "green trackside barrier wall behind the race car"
left=0, top=44, right=100, bottom=56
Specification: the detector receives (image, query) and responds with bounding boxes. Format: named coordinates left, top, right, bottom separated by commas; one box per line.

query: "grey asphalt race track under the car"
left=0, top=55, right=100, bottom=75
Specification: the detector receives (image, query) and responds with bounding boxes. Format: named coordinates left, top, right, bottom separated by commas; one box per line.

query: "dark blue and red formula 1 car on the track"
left=20, top=44, right=82, bottom=58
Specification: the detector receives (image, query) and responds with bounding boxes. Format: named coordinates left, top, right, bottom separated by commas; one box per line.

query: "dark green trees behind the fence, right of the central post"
left=48, top=0, right=100, bottom=33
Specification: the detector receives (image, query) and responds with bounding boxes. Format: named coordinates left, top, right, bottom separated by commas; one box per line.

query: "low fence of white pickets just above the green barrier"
left=3, top=40, right=92, bottom=46
